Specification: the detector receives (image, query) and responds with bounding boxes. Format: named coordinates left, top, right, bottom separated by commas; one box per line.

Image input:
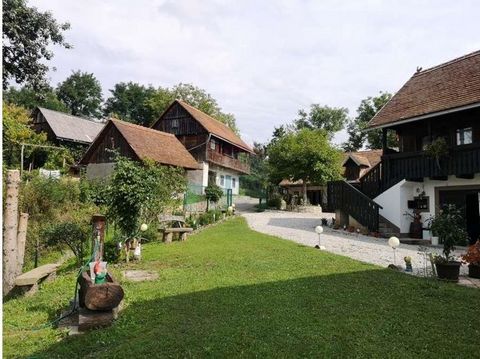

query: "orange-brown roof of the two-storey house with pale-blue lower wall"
left=152, top=100, right=254, bottom=153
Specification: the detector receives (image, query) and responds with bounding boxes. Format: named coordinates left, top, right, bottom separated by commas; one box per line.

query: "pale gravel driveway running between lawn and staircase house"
left=242, top=211, right=467, bottom=276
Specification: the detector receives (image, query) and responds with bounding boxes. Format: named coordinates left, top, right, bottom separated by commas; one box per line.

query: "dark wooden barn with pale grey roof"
left=32, top=107, right=105, bottom=148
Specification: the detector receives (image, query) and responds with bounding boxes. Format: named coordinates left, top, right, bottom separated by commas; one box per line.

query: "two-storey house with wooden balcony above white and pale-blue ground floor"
left=152, top=100, right=254, bottom=195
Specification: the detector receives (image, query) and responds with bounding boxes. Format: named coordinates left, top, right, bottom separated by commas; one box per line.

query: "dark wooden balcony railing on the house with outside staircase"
left=382, top=143, right=480, bottom=185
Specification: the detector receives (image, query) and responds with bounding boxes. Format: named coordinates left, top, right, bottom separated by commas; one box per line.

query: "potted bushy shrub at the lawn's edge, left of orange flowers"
left=431, top=205, right=468, bottom=281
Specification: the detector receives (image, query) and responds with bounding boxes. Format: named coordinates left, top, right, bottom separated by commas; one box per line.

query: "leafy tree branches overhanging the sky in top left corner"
left=2, top=0, right=71, bottom=89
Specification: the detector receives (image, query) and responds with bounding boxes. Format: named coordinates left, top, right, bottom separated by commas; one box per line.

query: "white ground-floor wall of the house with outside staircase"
left=374, top=173, right=480, bottom=235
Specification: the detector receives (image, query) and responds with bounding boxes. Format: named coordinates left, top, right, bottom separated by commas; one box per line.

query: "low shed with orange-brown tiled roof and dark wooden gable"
left=79, top=120, right=198, bottom=178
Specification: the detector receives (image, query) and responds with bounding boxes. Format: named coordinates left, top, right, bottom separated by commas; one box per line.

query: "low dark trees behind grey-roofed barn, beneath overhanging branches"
left=3, top=85, right=70, bottom=113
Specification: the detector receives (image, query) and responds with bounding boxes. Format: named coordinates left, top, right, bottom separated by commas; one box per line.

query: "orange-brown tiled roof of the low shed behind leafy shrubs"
left=80, top=120, right=198, bottom=169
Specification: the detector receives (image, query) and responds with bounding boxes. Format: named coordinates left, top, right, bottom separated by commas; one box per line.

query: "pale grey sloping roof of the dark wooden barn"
left=37, top=107, right=105, bottom=143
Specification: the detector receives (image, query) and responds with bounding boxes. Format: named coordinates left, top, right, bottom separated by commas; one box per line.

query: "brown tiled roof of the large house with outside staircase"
left=368, top=51, right=480, bottom=128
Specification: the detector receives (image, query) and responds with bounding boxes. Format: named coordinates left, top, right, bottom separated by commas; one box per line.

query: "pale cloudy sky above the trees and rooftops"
left=31, top=0, right=480, bottom=146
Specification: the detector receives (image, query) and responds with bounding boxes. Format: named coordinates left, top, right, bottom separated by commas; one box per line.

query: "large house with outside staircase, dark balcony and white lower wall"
left=328, top=51, right=480, bottom=243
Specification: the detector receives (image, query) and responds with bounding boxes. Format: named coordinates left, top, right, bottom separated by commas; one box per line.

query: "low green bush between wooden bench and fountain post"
left=43, top=222, right=91, bottom=264
